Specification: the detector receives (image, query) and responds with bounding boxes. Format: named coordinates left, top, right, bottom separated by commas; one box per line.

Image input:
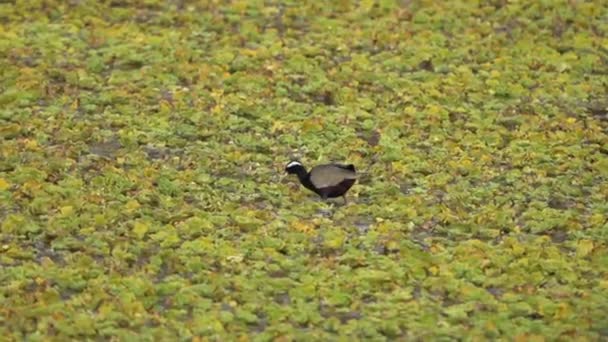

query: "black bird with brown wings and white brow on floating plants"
left=285, top=160, right=357, bottom=204
